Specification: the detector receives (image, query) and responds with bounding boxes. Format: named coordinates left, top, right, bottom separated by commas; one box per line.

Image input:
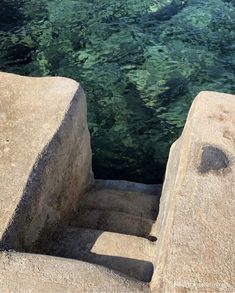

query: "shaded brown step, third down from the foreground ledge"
left=79, top=188, right=160, bottom=220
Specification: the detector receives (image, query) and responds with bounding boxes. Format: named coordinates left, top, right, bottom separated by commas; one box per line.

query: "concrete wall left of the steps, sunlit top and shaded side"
left=0, top=73, right=93, bottom=250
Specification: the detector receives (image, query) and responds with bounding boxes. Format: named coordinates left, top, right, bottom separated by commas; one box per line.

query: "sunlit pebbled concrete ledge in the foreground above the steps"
left=0, top=252, right=150, bottom=293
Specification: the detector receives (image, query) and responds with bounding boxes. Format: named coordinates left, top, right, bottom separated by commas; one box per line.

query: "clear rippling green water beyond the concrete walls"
left=0, top=0, right=235, bottom=183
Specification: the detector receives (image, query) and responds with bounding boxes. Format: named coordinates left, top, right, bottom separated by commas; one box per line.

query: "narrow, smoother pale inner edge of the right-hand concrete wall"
left=150, top=91, right=235, bottom=292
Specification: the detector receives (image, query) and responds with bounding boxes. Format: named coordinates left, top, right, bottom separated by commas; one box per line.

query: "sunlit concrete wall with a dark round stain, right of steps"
left=151, top=92, right=235, bottom=293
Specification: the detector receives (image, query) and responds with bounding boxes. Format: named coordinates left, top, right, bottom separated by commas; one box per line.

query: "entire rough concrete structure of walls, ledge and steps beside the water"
left=0, top=73, right=235, bottom=293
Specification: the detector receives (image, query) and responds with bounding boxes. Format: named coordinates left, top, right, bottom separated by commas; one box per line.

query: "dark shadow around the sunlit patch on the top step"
left=34, top=226, right=154, bottom=282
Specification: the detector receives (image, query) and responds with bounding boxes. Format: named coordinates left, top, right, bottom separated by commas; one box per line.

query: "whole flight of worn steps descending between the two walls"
left=36, top=180, right=161, bottom=282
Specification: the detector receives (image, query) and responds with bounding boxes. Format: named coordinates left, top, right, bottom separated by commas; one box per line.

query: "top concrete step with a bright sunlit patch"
left=42, top=226, right=156, bottom=282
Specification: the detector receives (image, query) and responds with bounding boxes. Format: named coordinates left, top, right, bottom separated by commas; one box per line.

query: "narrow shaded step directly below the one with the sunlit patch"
left=71, top=208, right=154, bottom=238
